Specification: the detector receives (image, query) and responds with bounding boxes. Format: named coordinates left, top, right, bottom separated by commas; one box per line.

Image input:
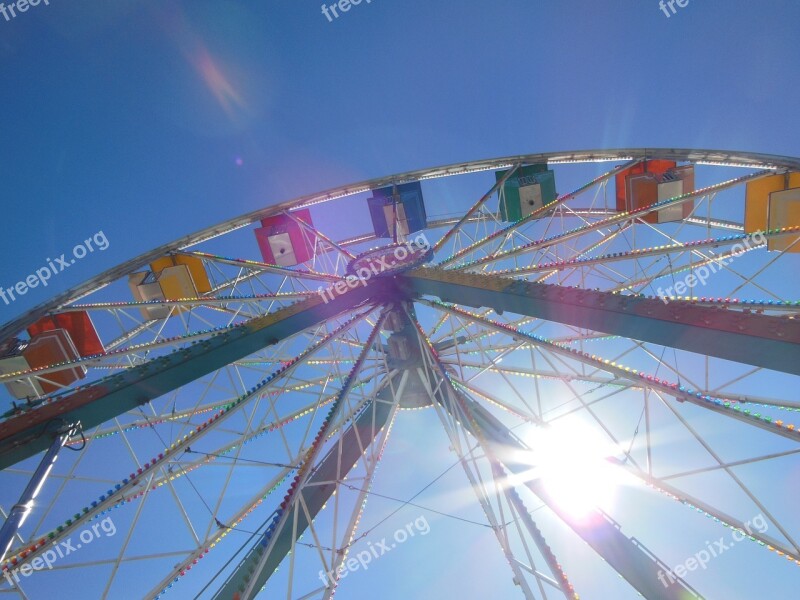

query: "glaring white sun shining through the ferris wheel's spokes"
left=525, top=421, right=627, bottom=519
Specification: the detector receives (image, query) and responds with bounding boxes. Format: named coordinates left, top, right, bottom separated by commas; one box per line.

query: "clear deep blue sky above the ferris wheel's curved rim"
left=0, top=0, right=800, bottom=598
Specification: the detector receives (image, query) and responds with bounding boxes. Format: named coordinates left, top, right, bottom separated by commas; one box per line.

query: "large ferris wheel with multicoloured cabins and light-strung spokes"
left=0, top=149, right=800, bottom=600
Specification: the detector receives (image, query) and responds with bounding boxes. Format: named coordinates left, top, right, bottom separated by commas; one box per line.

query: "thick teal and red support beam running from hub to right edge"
left=401, top=268, right=800, bottom=375
